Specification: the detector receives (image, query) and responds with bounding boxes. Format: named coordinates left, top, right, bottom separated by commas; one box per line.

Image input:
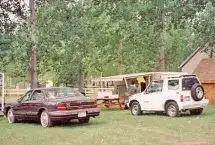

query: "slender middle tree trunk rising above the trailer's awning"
left=117, top=39, right=123, bottom=74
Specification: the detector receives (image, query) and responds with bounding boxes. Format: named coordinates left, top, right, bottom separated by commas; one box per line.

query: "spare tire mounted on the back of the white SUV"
left=191, top=84, right=205, bottom=101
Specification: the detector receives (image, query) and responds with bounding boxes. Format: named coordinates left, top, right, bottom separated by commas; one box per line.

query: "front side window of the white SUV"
left=146, top=81, right=163, bottom=94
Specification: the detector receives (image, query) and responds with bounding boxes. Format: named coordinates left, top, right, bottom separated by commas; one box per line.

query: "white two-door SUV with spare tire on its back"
left=128, top=75, right=209, bottom=117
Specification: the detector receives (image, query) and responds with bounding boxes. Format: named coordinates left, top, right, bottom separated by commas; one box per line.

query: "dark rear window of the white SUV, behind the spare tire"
left=182, top=77, right=199, bottom=91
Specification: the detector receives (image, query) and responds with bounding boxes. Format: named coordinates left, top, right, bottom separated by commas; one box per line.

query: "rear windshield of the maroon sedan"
left=45, top=87, right=84, bottom=99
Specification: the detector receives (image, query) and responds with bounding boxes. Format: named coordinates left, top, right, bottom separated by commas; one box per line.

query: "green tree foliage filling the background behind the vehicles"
left=0, top=0, right=215, bottom=84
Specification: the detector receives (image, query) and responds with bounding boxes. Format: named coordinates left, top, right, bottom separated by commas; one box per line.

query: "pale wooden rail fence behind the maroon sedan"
left=5, top=88, right=114, bottom=102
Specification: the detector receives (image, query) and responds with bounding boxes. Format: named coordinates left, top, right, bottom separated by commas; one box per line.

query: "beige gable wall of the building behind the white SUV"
left=182, top=51, right=209, bottom=74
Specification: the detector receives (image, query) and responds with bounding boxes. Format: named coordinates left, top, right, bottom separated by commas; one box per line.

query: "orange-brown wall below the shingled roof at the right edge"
left=202, top=83, right=215, bottom=104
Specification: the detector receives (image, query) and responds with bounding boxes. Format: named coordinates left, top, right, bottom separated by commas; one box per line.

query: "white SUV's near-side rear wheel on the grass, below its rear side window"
left=165, top=102, right=180, bottom=117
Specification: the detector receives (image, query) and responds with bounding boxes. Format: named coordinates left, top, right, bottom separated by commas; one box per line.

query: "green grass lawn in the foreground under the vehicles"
left=0, top=106, right=215, bottom=145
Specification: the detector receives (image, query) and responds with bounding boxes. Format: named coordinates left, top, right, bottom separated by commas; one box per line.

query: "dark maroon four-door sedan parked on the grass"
left=4, top=87, right=100, bottom=127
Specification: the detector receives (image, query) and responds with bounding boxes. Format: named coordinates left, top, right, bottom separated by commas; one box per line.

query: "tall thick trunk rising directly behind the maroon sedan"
left=29, top=0, right=37, bottom=89
